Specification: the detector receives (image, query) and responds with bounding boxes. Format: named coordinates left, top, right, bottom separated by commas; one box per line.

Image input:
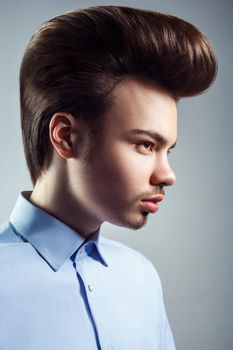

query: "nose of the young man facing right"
left=151, top=158, right=176, bottom=187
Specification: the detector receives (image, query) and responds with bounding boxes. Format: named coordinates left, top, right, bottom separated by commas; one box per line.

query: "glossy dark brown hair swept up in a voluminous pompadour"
left=20, top=6, right=217, bottom=184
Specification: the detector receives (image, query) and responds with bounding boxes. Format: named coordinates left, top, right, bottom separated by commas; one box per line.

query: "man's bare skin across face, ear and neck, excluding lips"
left=30, top=78, right=177, bottom=237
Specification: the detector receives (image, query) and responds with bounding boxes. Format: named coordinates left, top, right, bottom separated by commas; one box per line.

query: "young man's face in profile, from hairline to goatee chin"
left=72, top=79, right=177, bottom=229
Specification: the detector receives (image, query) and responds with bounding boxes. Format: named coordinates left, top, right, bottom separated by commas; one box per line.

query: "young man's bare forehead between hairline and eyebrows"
left=104, top=78, right=177, bottom=142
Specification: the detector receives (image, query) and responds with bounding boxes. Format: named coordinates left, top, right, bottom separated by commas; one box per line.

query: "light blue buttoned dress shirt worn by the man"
left=0, top=192, right=175, bottom=350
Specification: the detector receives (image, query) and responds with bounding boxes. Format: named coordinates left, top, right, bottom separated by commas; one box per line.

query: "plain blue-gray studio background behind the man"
left=0, top=0, right=233, bottom=350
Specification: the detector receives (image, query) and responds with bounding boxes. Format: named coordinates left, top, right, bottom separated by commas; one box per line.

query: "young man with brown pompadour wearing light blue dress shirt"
left=0, top=6, right=217, bottom=350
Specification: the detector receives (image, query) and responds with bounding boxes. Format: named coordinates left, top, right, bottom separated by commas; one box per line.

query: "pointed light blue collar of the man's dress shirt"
left=10, top=192, right=108, bottom=271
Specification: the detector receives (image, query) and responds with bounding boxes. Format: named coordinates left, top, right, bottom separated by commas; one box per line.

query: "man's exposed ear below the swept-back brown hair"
left=49, top=112, right=78, bottom=159
